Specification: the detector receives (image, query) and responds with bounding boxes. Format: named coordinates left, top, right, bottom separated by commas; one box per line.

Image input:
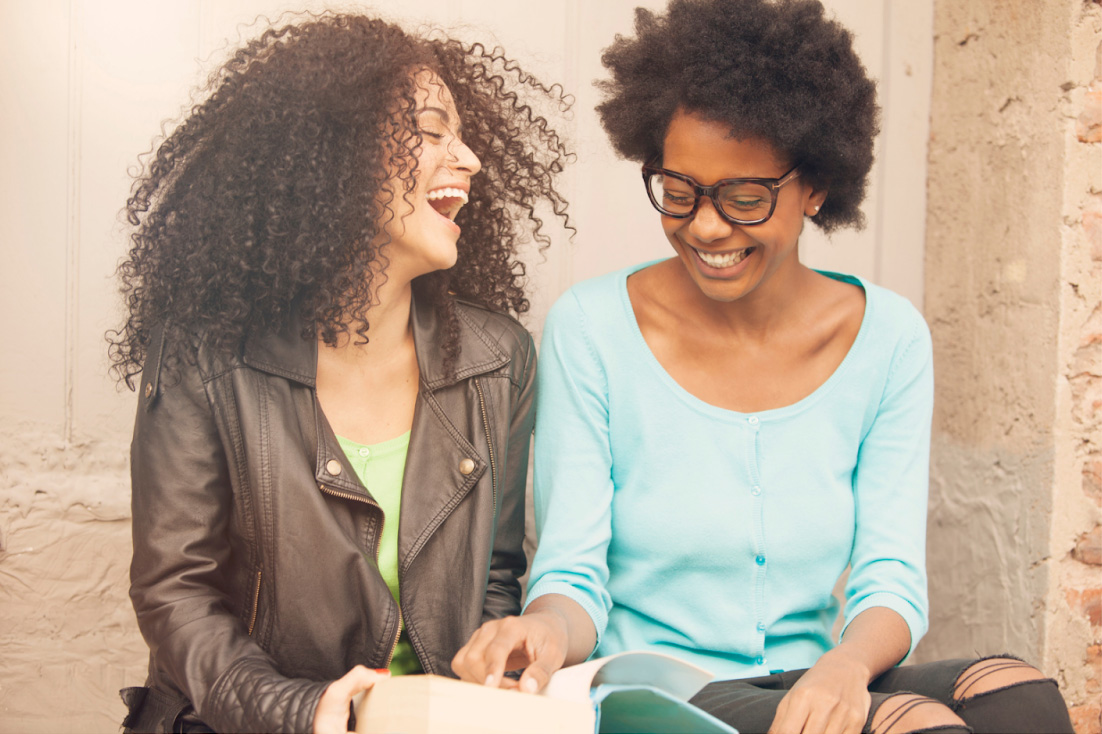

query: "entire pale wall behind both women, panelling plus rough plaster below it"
left=0, top=0, right=933, bottom=732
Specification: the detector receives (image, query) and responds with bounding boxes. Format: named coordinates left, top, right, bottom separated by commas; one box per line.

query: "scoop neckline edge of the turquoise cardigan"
left=617, top=259, right=873, bottom=421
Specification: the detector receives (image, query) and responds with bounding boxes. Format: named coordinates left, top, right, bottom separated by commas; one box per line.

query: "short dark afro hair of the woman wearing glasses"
left=597, top=0, right=879, bottom=233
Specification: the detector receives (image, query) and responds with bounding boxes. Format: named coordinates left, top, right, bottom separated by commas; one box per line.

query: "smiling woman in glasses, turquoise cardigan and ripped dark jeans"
left=453, top=0, right=1071, bottom=733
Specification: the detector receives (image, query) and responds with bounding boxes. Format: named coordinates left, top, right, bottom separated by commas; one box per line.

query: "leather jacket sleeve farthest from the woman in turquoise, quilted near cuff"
left=130, top=332, right=327, bottom=732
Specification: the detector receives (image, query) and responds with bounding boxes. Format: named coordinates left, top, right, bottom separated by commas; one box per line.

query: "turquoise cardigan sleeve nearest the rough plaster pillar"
left=842, top=310, right=933, bottom=655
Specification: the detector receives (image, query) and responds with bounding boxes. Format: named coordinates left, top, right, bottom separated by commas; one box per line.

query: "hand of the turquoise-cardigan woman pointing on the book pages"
left=452, top=609, right=570, bottom=693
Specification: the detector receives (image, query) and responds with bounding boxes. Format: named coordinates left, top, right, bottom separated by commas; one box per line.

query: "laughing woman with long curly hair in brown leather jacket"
left=110, top=14, right=569, bottom=732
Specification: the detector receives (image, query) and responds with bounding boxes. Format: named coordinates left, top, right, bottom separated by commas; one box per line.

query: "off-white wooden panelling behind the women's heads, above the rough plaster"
left=0, top=0, right=932, bottom=436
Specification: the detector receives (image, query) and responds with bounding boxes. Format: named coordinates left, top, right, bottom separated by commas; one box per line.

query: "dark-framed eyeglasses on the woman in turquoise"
left=642, top=163, right=800, bottom=225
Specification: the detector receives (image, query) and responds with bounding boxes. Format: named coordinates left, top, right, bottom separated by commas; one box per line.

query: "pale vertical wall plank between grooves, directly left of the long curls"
left=71, top=0, right=198, bottom=435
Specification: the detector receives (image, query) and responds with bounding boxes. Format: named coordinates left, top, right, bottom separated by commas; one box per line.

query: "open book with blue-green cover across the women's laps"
left=356, top=651, right=736, bottom=734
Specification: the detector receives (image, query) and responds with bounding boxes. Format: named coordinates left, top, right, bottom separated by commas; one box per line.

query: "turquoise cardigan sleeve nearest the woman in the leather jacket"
left=528, top=292, right=613, bottom=640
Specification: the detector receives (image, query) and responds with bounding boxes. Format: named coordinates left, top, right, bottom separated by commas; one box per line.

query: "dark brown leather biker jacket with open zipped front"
left=125, top=295, right=536, bottom=732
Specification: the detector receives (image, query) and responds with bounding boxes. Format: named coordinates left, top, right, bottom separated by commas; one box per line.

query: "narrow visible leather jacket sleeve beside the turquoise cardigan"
left=483, top=332, right=536, bottom=622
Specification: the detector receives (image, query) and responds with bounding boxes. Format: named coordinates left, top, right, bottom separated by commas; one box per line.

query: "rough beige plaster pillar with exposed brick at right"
left=921, top=0, right=1102, bottom=732
